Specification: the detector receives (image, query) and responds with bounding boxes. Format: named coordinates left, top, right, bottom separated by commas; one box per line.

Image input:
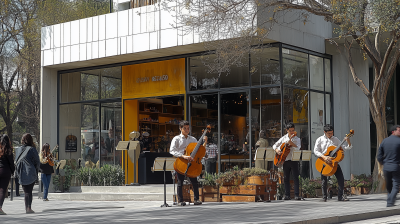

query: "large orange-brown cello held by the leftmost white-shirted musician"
left=174, top=125, right=211, bottom=178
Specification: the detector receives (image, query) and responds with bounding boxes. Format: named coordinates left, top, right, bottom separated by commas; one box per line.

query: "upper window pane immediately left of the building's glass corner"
left=250, top=47, right=281, bottom=86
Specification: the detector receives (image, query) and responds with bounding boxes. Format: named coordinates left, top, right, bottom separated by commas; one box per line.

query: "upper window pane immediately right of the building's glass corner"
left=282, top=48, right=308, bottom=87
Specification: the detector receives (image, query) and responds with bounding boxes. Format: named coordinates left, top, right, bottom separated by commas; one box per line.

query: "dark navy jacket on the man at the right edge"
left=377, top=135, right=400, bottom=171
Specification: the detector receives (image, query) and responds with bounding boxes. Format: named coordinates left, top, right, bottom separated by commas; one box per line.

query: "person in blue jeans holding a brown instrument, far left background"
left=39, top=143, right=54, bottom=201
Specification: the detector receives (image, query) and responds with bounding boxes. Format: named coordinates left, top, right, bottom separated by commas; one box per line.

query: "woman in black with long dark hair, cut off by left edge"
left=0, top=135, right=15, bottom=215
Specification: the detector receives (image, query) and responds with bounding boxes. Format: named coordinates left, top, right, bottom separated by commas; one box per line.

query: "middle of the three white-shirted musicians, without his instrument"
left=272, top=122, right=301, bottom=200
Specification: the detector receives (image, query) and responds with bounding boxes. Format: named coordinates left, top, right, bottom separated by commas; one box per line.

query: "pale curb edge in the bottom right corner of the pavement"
left=285, top=208, right=400, bottom=224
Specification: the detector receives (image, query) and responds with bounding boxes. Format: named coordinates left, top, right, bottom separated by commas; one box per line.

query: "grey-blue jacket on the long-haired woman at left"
left=15, top=146, right=40, bottom=185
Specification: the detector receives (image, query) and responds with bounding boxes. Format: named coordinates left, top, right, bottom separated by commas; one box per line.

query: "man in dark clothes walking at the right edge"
left=377, top=125, right=400, bottom=207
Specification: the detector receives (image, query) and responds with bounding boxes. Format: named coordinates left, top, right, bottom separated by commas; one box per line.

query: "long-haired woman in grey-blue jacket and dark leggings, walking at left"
left=15, top=133, right=40, bottom=214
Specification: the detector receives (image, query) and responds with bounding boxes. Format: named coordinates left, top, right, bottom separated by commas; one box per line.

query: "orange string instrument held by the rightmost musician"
left=315, top=130, right=354, bottom=177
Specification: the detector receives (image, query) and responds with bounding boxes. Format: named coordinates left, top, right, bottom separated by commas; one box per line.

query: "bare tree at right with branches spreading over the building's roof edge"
left=162, top=0, right=400, bottom=192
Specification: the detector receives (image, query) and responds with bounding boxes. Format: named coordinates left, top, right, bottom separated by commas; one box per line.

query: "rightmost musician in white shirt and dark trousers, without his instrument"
left=314, top=124, right=353, bottom=202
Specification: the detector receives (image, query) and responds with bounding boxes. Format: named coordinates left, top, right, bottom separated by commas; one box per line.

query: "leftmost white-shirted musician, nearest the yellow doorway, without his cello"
left=169, top=120, right=207, bottom=206
